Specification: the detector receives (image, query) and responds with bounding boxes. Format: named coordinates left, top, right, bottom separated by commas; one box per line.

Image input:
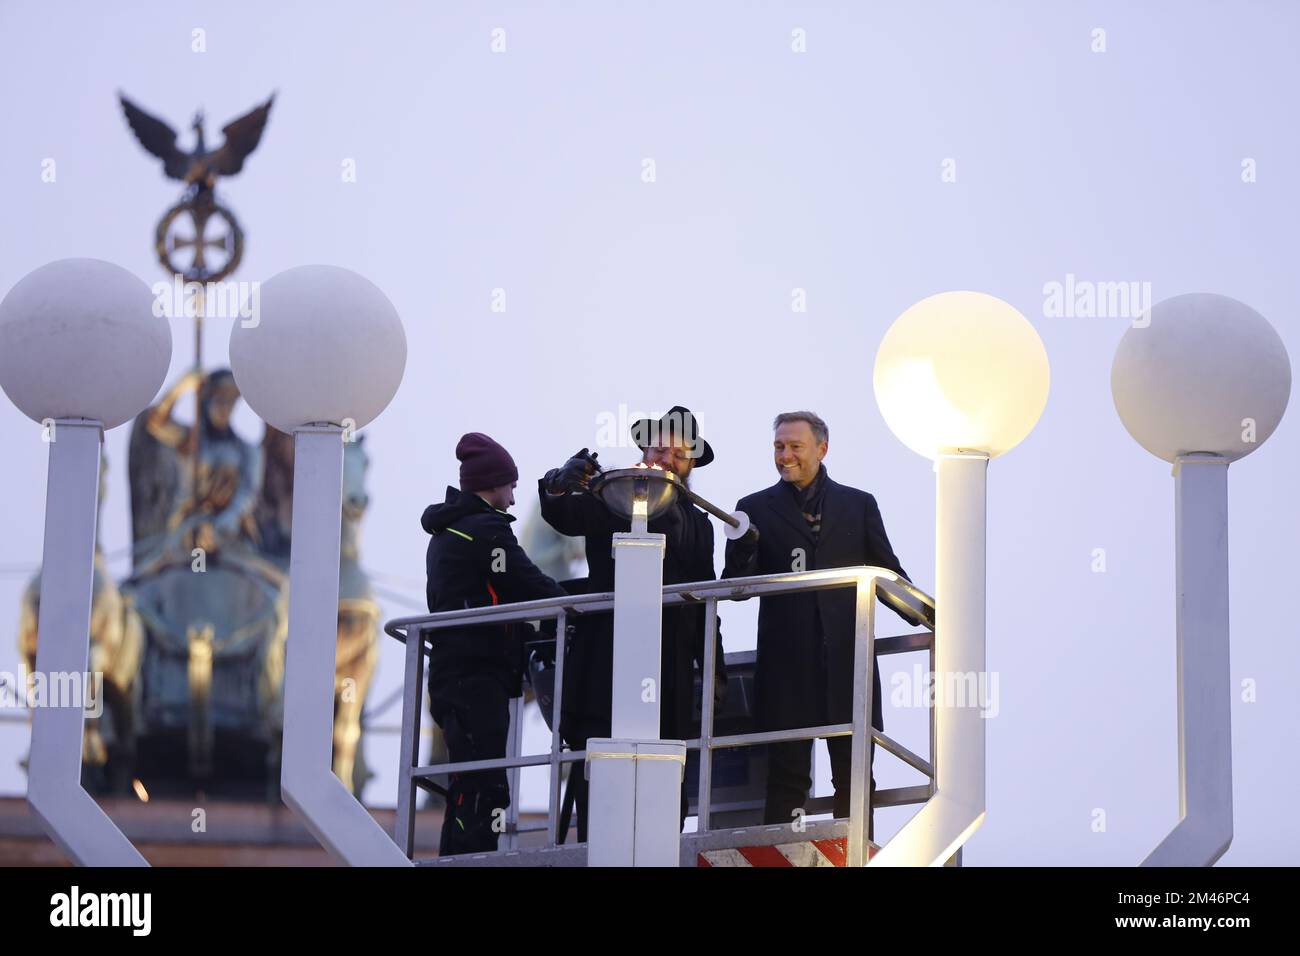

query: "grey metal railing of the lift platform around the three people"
left=384, top=567, right=936, bottom=866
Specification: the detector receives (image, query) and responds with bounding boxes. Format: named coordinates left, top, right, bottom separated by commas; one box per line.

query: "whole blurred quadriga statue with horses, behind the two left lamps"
left=18, top=369, right=380, bottom=799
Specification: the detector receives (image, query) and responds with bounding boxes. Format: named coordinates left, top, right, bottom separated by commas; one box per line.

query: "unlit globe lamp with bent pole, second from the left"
left=230, top=265, right=411, bottom=866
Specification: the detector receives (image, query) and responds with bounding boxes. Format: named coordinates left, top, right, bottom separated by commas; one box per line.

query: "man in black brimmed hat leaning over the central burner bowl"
left=538, top=405, right=727, bottom=840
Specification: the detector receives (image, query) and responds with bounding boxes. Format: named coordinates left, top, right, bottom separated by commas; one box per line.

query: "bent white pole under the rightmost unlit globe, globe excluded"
left=1143, top=454, right=1232, bottom=866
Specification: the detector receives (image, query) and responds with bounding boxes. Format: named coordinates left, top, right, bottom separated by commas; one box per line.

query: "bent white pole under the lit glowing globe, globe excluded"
left=868, top=453, right=988, bottom=866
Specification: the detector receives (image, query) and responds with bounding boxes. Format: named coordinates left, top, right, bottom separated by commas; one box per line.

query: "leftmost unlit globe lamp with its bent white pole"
left=0, top=259, right=172, bottom=866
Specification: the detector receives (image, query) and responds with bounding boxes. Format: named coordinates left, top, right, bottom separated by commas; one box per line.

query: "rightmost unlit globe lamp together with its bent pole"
left=1110, top=293, right=1291, bottom=866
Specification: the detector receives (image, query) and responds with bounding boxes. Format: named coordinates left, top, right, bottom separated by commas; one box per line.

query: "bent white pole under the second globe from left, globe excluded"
left=281, top=425, right=411, bottom=866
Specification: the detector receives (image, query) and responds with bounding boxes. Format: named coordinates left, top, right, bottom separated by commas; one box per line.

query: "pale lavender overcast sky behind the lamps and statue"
left=0, top=0, right=1300, bottom=865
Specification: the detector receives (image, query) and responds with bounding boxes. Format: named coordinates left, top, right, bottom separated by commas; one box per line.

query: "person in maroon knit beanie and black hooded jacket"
left=420, top=432, right=564, bottom=856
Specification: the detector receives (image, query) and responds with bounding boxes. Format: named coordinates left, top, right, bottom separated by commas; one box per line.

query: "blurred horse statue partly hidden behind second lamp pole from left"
left=254, top=425, right=380, bottom=795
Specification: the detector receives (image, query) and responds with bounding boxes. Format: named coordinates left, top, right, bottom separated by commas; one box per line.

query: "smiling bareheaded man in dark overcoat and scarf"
left=723, top=411, right=915, bottom=826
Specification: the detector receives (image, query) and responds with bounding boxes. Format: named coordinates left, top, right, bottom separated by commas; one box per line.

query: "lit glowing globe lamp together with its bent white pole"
left=870, top=291, right=1050, bottom=866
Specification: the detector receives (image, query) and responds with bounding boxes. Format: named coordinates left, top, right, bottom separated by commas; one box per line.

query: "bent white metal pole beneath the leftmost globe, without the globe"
left=27, top=419, right=148, bottom=866
